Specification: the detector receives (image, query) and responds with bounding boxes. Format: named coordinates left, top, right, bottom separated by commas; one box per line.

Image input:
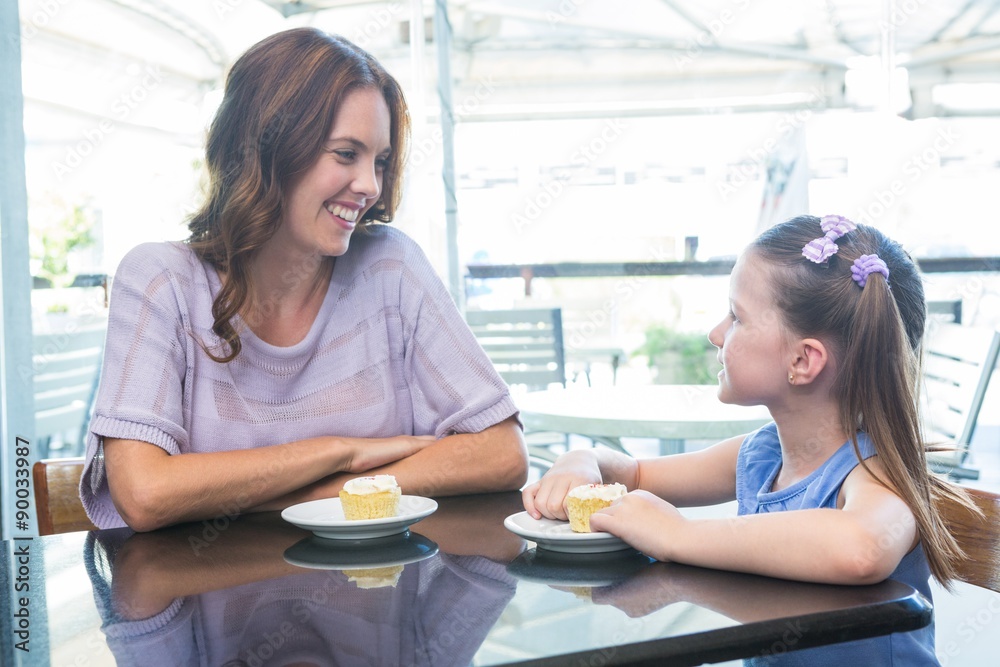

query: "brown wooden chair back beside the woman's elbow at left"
left=31, top=457, right=96, bottom=535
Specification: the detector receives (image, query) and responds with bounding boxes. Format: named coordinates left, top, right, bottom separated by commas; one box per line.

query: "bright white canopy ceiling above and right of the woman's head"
left=260, top=0, right=1000, bottom=117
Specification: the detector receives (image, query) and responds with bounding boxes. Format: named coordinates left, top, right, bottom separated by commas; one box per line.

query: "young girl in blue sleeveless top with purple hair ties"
left=523, top=216, right=976, bottom=665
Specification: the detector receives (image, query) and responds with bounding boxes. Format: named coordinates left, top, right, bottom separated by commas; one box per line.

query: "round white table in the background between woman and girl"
left=516, top=385, right=771, bottom=453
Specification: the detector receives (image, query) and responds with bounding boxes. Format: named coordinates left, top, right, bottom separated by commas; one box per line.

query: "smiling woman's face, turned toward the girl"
left=272, top=88, right=391, bottom=257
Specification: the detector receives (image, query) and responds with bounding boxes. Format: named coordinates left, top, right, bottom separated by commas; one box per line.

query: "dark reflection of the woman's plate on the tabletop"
left=284, top=532, right=438, bottom=570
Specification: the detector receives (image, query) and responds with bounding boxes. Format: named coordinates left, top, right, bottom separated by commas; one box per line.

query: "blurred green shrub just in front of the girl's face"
left=635, top=324, right=719, bottom=384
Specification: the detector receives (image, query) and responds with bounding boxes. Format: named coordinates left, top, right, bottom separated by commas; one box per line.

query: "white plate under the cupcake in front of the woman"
left=281, top=496, right=437, bottom=540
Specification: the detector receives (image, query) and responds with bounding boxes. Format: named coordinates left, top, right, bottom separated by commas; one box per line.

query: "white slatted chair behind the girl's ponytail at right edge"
left=922, top=322, right=1000, bottom=479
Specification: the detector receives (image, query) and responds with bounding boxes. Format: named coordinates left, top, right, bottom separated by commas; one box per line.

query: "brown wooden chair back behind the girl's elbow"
left=939, top=488, right=1000, bottom=592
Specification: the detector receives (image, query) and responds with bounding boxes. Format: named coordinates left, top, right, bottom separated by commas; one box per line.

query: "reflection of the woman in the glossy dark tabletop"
left=85, top=496, right=524, bottom=667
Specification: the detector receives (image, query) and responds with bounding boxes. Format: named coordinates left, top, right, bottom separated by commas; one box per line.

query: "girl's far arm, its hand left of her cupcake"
left=522, top=435, right=746, bottom=521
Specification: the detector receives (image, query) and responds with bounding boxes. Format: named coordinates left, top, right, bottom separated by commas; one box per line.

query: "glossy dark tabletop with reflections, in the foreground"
left=0, top=493, right=932, bottom=667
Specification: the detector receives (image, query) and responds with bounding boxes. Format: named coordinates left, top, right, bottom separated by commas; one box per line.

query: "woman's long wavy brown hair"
left=187, top=28, right=410, bottom=363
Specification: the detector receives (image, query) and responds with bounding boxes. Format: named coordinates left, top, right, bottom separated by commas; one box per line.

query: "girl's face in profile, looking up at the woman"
left=708, top=253, right=792, bottom=407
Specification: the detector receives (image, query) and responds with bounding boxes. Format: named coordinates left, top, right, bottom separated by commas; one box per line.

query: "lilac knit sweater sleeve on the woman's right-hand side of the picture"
left=392, top=235, right=517, bottom=437
